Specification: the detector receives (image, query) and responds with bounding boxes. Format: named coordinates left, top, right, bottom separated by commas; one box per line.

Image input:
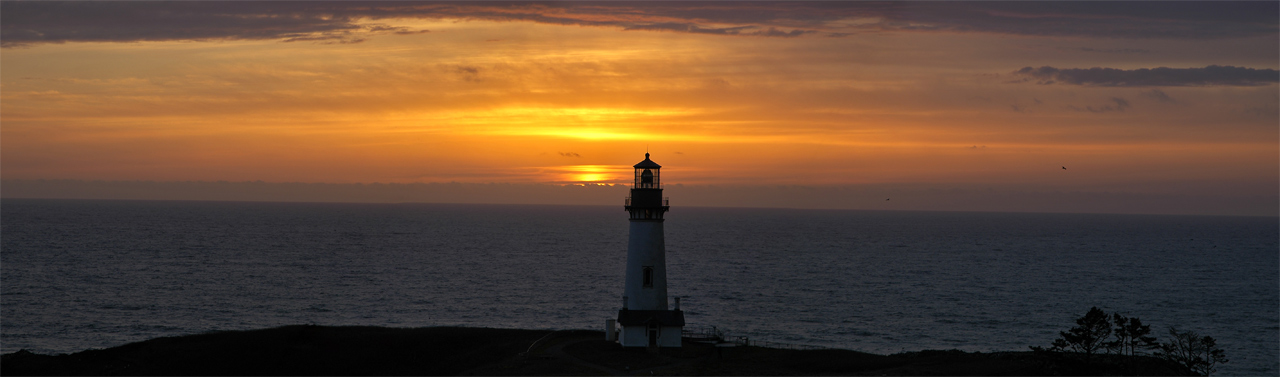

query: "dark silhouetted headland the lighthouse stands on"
left=0, top=325, right=1189, bottom=376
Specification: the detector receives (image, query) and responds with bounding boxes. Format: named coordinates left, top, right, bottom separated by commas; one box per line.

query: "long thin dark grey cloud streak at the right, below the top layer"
left=1014, top=65, right=1280, bottom=87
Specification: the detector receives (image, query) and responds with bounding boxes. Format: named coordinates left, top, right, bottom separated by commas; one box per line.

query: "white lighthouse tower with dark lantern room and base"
left=617, top=153, right=685, bottom=348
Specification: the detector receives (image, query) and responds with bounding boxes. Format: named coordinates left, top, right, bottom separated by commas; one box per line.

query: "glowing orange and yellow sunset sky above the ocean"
left=0, top=1, right=1280, bottom=216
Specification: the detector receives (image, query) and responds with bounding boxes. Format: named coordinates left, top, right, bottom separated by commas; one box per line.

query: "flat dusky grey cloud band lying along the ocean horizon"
left=0, top=179, right=1280, bottom=216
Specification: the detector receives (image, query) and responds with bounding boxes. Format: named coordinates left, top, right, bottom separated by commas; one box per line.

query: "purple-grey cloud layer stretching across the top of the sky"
left=0, top=1, right=1280, bottom=47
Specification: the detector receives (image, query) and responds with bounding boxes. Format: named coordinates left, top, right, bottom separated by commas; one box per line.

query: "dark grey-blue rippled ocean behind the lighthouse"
left=0, top=198, right=1280, bottom=376
